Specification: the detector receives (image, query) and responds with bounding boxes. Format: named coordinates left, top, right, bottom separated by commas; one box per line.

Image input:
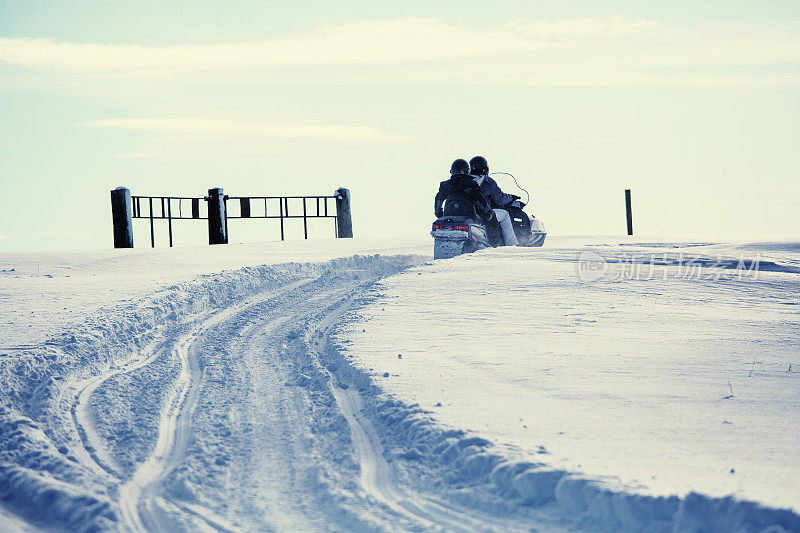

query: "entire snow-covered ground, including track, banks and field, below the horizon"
left=0, top=238, right=800, bottom=531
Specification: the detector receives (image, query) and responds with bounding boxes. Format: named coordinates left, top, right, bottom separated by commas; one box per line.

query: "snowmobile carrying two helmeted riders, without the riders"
left=431, top=172, right=547, bottom=259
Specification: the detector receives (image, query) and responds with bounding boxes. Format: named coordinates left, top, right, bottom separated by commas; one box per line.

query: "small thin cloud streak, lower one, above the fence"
left=81, top=118, right=409, bottom=142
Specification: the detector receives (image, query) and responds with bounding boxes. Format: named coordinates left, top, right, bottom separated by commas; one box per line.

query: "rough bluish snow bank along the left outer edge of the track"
left=0, top=251, right=418, bottom=531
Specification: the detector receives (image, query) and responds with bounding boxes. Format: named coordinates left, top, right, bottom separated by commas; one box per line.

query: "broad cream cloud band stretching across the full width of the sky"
left=0, top=17, right=800, bottom=88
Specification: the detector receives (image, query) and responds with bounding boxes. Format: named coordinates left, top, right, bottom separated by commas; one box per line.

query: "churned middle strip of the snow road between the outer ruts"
left=166, top=279, right=387, bottom=530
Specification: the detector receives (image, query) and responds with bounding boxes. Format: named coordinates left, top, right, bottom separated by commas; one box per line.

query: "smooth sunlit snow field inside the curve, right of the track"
left=338, top=241, right=800, bottom=525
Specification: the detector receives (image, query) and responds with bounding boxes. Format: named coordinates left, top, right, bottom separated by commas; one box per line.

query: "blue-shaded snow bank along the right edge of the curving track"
left=327, top=347, right=800, bottom=533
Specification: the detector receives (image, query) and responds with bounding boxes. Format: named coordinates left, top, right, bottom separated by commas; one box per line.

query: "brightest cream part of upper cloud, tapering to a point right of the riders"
left=0, top=18, right=553, bottom=72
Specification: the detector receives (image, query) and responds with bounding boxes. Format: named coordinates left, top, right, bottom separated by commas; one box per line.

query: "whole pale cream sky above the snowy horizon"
left=0, top=0, right=800, bottom=250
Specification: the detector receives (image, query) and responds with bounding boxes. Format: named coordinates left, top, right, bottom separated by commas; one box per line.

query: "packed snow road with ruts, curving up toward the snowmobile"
left=93, top=264, right=544, bottom=531
